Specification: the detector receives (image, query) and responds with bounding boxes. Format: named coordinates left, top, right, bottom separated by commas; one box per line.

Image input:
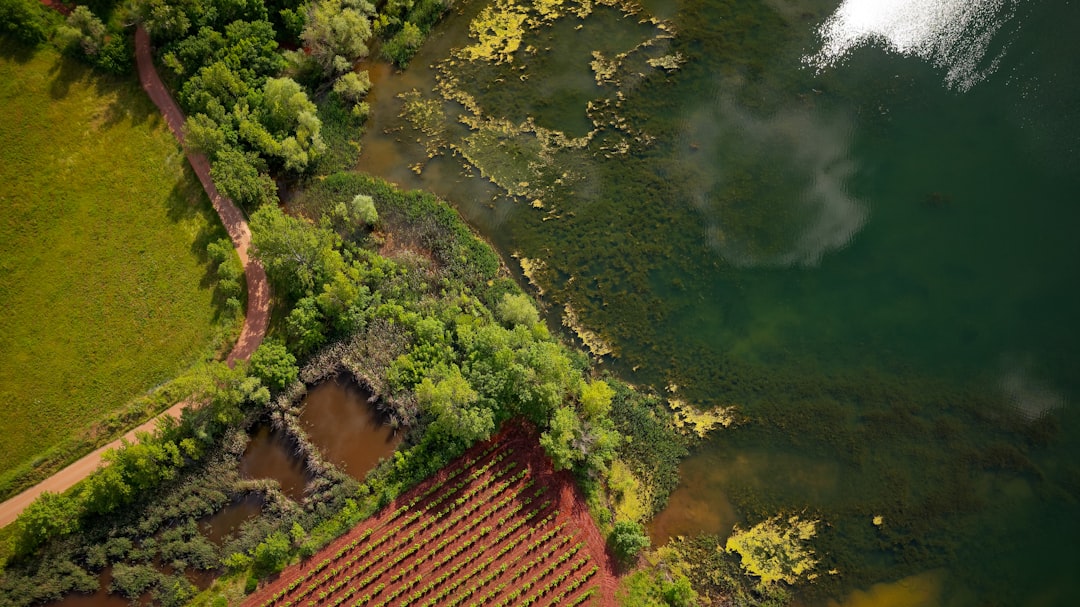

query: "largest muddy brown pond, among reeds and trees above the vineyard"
left=300, top=378, right=401, bottom=480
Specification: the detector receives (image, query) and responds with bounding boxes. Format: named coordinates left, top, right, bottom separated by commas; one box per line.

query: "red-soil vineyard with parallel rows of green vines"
left=244, top=423, right=617, bottom=607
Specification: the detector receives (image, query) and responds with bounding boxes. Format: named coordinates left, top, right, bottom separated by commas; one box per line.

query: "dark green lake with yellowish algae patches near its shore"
left=360, top=0, right=1080, bottom=606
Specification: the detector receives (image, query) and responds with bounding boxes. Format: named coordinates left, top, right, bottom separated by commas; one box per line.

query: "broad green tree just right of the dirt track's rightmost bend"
left=251, top=205, right=345, bottom=299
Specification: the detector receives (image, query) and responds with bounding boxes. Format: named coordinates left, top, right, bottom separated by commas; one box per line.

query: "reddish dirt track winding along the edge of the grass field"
left=0, top=24, right=270, bottom=527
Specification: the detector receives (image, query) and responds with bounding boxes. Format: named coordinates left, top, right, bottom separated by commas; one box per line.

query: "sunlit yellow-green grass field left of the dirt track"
left=0, top=37, right=235, bottom=493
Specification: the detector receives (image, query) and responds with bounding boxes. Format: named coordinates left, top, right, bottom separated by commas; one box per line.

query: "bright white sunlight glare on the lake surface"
left=804, top=0, right=1016, bottom=92
